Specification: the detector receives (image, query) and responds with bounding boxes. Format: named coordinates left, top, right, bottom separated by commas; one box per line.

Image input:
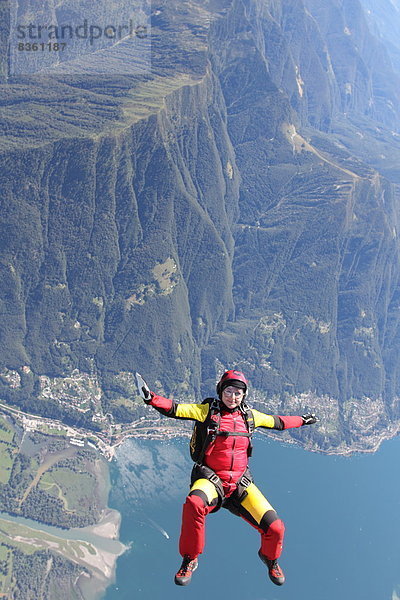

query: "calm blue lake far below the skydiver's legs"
left=104, top=434, right=400, bottom=600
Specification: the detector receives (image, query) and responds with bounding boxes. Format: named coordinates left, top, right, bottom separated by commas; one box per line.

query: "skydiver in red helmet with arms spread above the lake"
left=138, top=369, right=318, bottom=586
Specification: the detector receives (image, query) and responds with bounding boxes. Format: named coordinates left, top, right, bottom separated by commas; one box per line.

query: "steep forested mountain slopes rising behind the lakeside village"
left=0, top=0, right=400, bottom=450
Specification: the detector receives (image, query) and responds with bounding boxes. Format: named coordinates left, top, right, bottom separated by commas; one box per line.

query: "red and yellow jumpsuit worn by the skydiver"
left=149, top=394, right=303, bottom=560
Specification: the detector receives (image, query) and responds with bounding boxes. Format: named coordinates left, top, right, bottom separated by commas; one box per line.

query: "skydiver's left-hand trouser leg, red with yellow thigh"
left=179, top=479, right=218, bottom=560
